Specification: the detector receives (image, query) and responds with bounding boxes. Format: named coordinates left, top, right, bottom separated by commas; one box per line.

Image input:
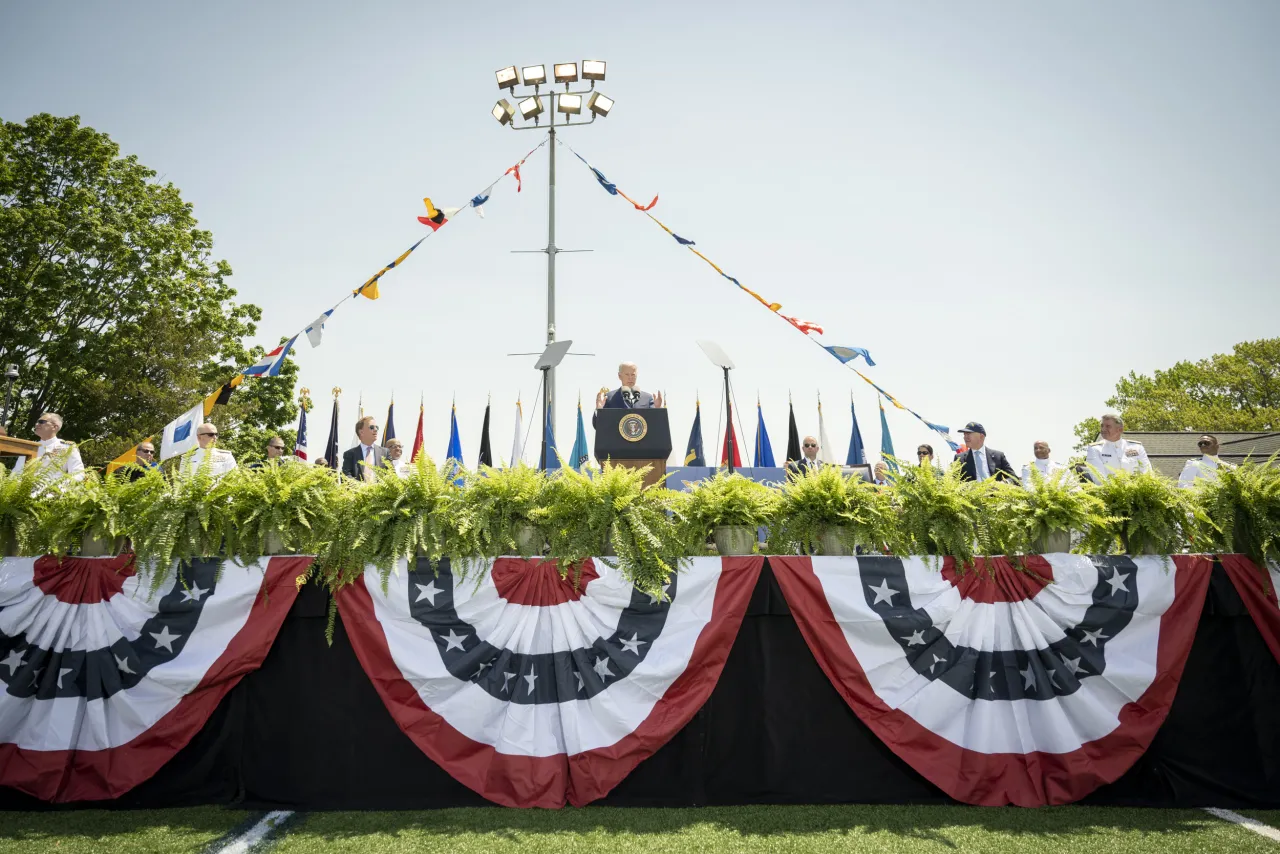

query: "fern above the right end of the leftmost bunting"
left=223, top=460, right=343, bottom=563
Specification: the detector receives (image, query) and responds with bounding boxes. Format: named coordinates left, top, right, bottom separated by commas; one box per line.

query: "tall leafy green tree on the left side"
left=0, top=114, right=297, bottom=462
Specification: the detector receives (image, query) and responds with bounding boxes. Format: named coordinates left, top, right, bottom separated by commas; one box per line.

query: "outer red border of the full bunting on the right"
left=769, top=554, right=1212, bottom=807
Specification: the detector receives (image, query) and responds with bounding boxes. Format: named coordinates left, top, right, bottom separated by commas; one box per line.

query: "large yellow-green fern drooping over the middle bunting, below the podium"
left=547, top=462, right=686, bottom=595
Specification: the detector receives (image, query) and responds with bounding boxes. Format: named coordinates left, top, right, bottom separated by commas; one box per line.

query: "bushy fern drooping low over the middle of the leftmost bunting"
left=128, top=456, right=237, bottom=590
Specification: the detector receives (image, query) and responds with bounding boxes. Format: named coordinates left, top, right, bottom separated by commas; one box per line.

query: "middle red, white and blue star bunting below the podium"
left=338, top=557, right=764, bottom=808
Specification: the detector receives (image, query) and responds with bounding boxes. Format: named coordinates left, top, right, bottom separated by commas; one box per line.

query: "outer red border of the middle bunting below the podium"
left=337, top=557, right=764, bottom=809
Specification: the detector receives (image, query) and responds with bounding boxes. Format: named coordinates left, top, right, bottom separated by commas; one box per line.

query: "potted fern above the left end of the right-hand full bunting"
left=769, top=466, right=893, bottom=554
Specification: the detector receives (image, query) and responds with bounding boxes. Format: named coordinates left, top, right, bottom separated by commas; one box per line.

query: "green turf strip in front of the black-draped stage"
left=0, top=807, right=1280, bottom=854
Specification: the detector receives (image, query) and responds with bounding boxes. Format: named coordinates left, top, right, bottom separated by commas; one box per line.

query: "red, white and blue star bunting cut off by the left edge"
left=0, top=556, right=311, bottom=802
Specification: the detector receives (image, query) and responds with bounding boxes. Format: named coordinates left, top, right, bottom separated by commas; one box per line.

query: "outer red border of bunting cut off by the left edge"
left=0, top=557, right=314, bottom=803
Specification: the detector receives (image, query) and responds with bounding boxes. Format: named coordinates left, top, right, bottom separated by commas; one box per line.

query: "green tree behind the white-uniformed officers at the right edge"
left=1075, top=338, right=1280, bottom=449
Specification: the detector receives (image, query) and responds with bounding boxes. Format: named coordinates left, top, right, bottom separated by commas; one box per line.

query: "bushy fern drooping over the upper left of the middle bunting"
left=340, top=453, right=480, bottom=580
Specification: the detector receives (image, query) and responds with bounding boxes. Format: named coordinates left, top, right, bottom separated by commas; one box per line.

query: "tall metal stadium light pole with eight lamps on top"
left=490, top=59, right=613, bottom=435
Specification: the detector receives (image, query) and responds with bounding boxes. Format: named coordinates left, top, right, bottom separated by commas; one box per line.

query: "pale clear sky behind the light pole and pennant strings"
left=0, top=0, right=1280, bottom=465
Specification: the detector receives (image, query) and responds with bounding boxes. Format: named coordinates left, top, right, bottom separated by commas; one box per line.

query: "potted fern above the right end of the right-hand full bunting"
left=1080, top=471, right=1204, bottom=554
